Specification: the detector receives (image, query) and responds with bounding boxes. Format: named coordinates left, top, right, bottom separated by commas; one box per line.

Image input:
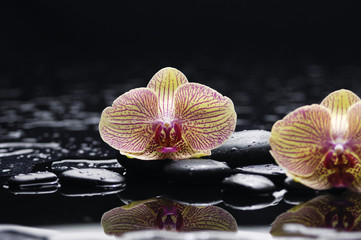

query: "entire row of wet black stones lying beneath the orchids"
left=0, top=130, right=314, bottom=206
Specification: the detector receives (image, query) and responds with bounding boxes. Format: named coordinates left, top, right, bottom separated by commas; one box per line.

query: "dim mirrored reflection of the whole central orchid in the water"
left=101, top=198, right=238, bottom=236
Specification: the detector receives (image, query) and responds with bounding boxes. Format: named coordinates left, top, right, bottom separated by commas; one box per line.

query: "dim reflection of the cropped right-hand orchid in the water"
left=271, top=191, right=361, bottom=236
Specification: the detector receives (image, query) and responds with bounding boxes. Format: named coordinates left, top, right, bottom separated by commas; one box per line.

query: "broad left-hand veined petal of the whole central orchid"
left=99, top=88, right=158, bottom=153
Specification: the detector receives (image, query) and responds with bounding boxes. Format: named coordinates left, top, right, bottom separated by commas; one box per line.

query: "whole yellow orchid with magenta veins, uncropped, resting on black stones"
left=99, top=67, right=237, bottom=160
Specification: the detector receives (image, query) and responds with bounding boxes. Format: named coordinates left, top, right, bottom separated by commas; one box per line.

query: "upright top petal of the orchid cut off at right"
left=320, top=89, right=360, bottom=138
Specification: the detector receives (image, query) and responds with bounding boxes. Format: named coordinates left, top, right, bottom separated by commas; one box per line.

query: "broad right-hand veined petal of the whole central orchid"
left=174, top=83, right=237, bottom=151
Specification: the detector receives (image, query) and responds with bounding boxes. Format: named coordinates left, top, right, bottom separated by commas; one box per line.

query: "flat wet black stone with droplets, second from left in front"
left=60, top=168, right=125, bottom=188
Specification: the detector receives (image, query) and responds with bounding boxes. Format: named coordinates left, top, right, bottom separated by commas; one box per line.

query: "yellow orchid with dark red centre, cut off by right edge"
left=270, top=89, right=361, bottom=192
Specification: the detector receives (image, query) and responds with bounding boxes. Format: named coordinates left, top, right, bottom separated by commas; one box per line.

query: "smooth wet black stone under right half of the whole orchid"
left=164, top=159, right=231, bottom=184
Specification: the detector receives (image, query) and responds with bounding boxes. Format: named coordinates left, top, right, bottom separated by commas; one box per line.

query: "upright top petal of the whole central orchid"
left=147, top=67, right=188, bottom=120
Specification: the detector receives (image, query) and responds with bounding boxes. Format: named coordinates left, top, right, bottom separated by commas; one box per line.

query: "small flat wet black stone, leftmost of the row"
left=7, top=172, right=58, bottom=190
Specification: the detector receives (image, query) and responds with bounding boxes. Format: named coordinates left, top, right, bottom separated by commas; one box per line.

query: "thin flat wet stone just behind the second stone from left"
left=51, top=159, right=124, bottom=173
